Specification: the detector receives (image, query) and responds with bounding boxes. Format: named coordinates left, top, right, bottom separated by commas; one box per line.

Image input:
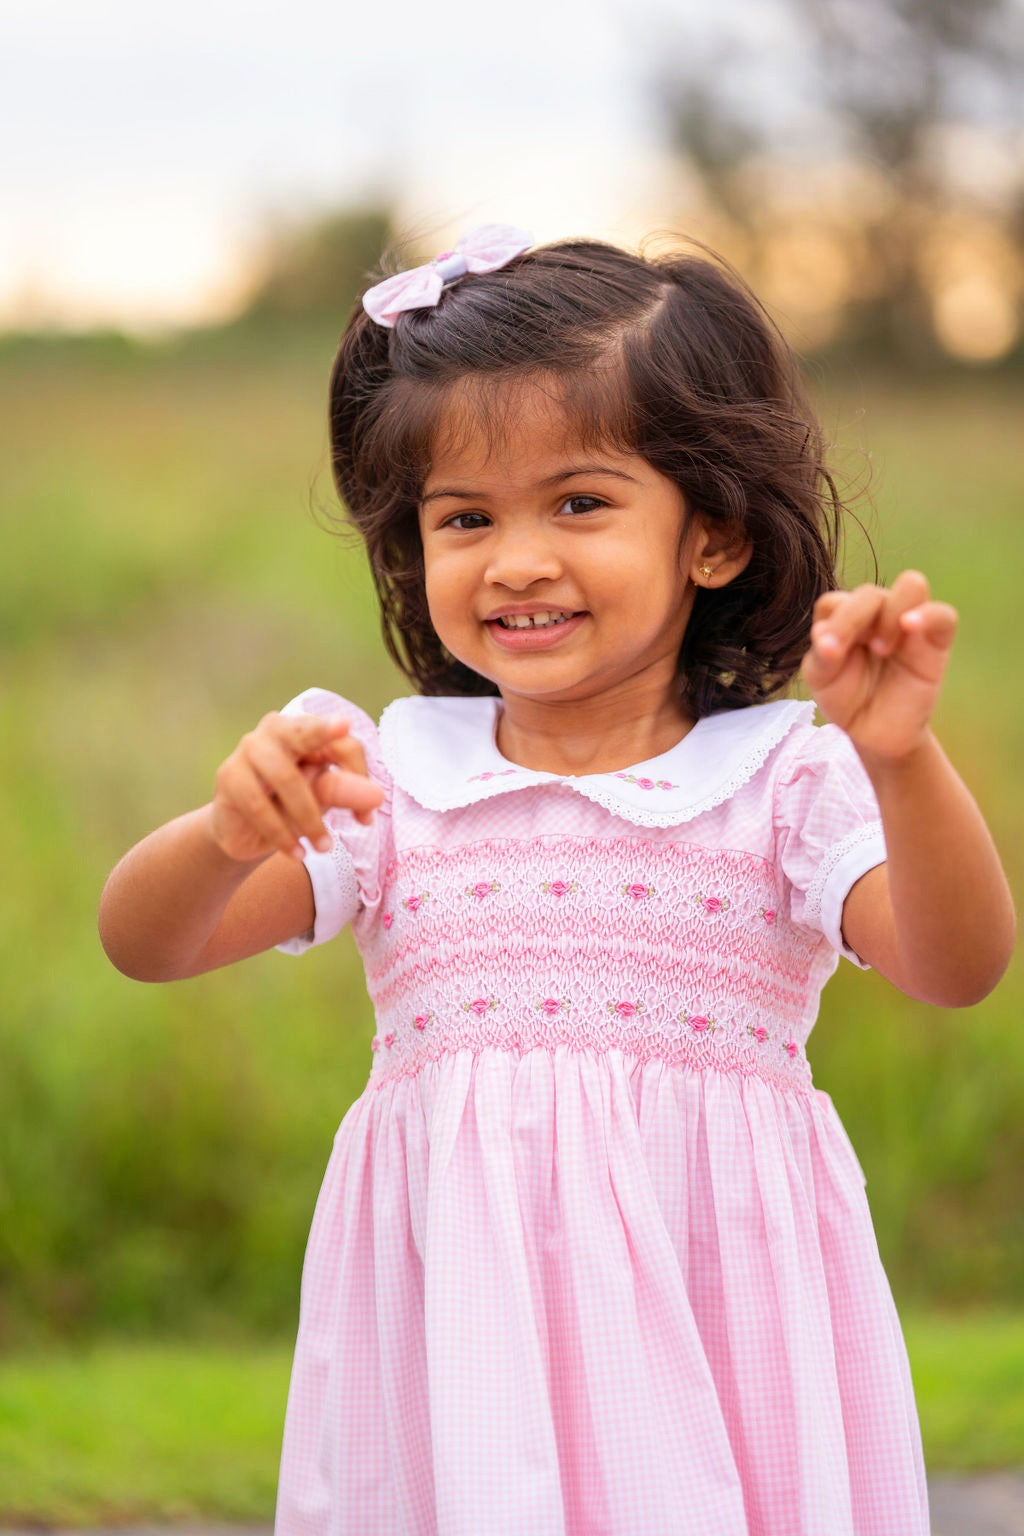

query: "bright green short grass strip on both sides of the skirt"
left=0, top=1313, right=1024, bottom=1525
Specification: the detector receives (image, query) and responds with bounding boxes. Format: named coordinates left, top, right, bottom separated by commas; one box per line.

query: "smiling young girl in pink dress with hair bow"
left=101, top=226, right=1013, bottom=1536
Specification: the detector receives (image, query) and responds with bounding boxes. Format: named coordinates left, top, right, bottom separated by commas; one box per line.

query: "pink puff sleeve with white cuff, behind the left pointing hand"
left=276, top=688, right=391, bottom=955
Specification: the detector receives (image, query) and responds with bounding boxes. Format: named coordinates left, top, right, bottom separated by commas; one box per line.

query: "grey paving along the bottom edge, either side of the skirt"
left=8, top=1471, right=1024, bottom=1536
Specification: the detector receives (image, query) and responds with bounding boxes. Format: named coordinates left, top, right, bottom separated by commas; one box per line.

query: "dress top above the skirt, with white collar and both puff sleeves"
left=277, top=690, right=884, bottom=1092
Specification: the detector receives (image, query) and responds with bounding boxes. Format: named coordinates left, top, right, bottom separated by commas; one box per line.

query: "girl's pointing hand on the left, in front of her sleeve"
left=209, top=711, right=384, bottom=863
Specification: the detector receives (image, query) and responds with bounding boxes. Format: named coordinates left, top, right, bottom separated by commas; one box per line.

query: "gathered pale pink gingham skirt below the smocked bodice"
left=275, top=1046, right=929, bottom=1536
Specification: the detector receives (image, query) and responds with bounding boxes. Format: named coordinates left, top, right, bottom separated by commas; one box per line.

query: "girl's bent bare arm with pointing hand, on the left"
left=100, top=714, right=382, bottom=982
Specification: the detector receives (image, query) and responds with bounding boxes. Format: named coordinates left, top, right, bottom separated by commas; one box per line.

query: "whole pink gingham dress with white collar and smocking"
left=275, top=690, right=929, bottom=1536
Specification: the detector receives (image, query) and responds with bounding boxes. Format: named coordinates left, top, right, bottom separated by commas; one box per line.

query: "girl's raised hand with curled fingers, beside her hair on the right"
left=800, top=571, right=958, bottom=760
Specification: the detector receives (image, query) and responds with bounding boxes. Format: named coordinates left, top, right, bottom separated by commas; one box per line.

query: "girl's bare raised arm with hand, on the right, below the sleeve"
left=803, top=571, right=1015, bottom=1008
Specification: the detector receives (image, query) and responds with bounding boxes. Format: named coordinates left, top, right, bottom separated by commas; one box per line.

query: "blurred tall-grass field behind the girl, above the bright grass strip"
left=0, top=330, right=1024, bottom=1347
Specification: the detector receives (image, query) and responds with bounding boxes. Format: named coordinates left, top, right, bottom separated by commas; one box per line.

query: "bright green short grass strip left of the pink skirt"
left=0, top=1344, right=289, bottom=1525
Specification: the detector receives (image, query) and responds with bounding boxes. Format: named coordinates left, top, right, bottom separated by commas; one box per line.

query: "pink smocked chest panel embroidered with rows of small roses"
left=361, top=833, right=835, bottom=1089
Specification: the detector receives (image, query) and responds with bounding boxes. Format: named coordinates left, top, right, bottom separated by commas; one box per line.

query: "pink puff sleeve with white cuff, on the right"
left=774, top=725, right=886, bottom=971
